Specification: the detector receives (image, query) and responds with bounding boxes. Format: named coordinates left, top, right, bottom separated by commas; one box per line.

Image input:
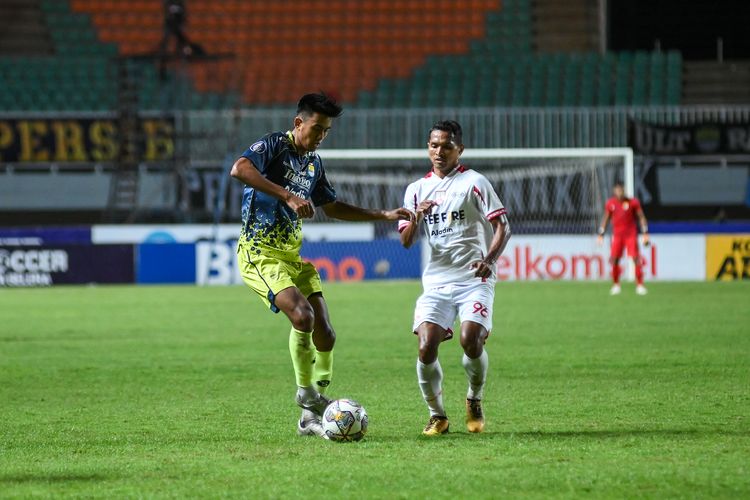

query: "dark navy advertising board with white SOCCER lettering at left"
left=0, top=245, right=135, bottom=287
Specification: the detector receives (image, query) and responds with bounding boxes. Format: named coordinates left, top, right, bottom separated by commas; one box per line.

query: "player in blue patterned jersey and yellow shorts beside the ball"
left=231, top=94, right=414, bottom=436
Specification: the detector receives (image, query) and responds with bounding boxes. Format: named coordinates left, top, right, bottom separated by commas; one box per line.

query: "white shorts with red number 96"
left=413, top=283, right=495, bottom=340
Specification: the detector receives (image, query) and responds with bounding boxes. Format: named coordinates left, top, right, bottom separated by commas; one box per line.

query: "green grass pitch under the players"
left=0, top=282, right=750, bottom=498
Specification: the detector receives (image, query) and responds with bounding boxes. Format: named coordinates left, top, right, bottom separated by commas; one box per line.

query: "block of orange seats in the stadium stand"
left=70, top=0, right=499, bottom=104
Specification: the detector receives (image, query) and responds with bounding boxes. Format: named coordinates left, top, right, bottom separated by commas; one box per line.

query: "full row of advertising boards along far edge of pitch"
left=0, top=224, right=750, bottom=287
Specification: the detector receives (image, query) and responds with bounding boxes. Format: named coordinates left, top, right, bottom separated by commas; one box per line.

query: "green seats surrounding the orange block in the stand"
left=0, top=0, right=682, bottom=110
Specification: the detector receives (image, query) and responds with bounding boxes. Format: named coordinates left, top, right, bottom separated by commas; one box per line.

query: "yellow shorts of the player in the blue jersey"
left=237, top=245, right=323, bottom=313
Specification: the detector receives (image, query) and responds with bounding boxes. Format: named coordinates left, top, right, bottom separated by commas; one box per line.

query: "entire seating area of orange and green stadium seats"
left=0, top=0, right=682, bottom=111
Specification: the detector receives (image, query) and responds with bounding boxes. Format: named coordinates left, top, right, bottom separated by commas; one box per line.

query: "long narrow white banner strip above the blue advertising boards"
left=91, top=223, right=375, bottom=245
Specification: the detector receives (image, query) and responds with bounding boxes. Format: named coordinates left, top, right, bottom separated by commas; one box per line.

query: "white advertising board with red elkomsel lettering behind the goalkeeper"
left=422, top=234, right=706, bottom=281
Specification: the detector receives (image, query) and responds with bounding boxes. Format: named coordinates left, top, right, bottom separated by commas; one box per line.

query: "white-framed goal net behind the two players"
left=316, top=148, right=633, bottom=236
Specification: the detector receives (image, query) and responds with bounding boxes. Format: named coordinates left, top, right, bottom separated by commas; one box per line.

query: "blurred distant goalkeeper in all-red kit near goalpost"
left=598, top=182, right=649, bottom=295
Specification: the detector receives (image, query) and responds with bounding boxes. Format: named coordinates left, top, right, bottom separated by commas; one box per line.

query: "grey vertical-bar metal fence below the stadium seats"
left=185, top=105, right=750, bottom=161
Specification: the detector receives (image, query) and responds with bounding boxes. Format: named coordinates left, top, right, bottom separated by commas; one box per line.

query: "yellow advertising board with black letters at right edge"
left=706, top=234, right=750, bottom=281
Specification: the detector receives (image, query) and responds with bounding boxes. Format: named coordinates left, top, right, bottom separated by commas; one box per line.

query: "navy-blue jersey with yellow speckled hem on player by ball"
left=240, top=132, right=336, bottom=261
